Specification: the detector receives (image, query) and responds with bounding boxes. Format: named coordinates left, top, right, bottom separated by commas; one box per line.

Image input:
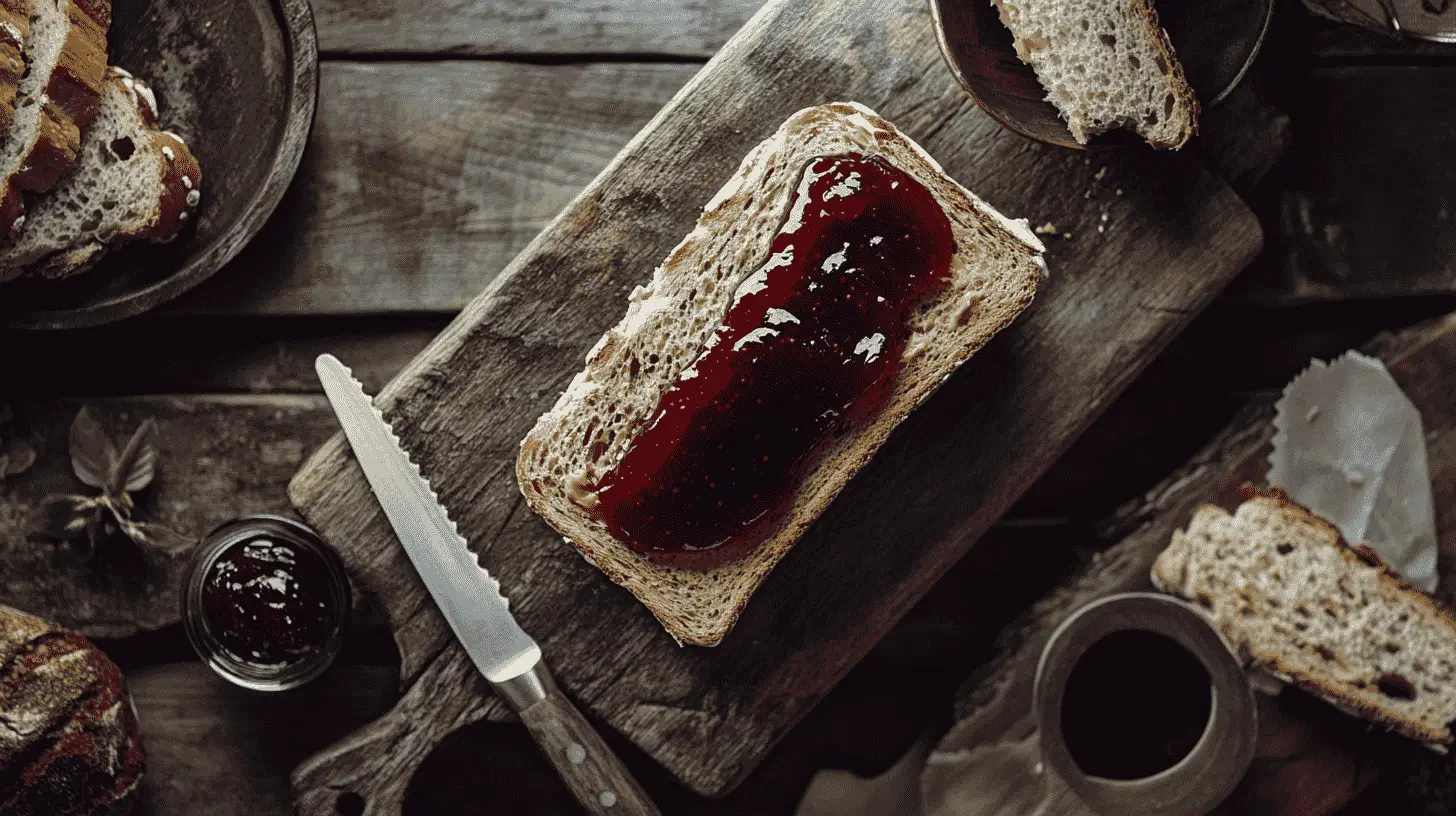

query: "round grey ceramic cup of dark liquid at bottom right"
left=1035, top=593, right=1258, bottom=816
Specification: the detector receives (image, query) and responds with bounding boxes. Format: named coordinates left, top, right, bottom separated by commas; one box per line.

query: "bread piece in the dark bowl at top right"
left=994, top=0, right=1198, bottom=149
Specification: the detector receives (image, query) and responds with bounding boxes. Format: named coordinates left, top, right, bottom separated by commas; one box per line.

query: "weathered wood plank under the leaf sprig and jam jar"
left=0, top=395, right=338, bottom=638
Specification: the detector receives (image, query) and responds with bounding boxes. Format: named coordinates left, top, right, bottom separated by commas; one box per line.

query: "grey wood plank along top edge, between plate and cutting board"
left=313, top=0, right=760, bottom=60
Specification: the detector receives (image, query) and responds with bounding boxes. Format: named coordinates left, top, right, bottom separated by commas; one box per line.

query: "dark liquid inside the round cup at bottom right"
left=1061, top=629, right=1213, bottom=780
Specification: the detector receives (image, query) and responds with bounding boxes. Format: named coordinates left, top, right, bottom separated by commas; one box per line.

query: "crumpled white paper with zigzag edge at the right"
left=1268, top=351, right=1436, bottom=592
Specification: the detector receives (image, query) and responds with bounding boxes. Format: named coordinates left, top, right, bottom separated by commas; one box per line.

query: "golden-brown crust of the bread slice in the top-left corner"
left=0, top=0, right=111, bottom=239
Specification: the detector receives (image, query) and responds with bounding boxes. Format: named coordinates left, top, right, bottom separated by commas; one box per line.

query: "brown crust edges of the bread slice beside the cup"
left=1152, top=485, right=1456, bottom=748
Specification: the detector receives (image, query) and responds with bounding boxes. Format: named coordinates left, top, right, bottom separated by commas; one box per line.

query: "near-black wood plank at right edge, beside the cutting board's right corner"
left=1230, top=66, right=1456, bottom=306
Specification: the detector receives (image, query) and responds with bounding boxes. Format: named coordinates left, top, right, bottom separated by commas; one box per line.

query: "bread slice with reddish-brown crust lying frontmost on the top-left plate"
left=0, top=68, right=202, bottom=280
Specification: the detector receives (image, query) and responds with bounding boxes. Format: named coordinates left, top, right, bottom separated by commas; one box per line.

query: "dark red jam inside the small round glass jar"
left=201, top=535, right=344, bottom=666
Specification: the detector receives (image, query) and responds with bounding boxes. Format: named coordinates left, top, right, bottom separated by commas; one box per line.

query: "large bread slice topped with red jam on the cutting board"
left=517, top=103, right=1045, bottom=646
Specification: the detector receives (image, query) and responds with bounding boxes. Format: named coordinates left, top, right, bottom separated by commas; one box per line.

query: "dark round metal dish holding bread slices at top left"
left=0, top=0, right=319, bottom=329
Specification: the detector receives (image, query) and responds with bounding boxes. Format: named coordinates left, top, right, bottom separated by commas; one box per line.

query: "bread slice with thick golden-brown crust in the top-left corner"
left=0, top=0, right=111, bottom=239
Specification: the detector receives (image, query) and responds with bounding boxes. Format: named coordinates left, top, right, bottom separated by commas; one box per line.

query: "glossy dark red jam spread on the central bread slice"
left=597, top=153, right=955, bottom=570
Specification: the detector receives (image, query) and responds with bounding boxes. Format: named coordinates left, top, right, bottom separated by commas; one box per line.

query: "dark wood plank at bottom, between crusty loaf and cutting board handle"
left=127, top=662, right=399, bottom=816
